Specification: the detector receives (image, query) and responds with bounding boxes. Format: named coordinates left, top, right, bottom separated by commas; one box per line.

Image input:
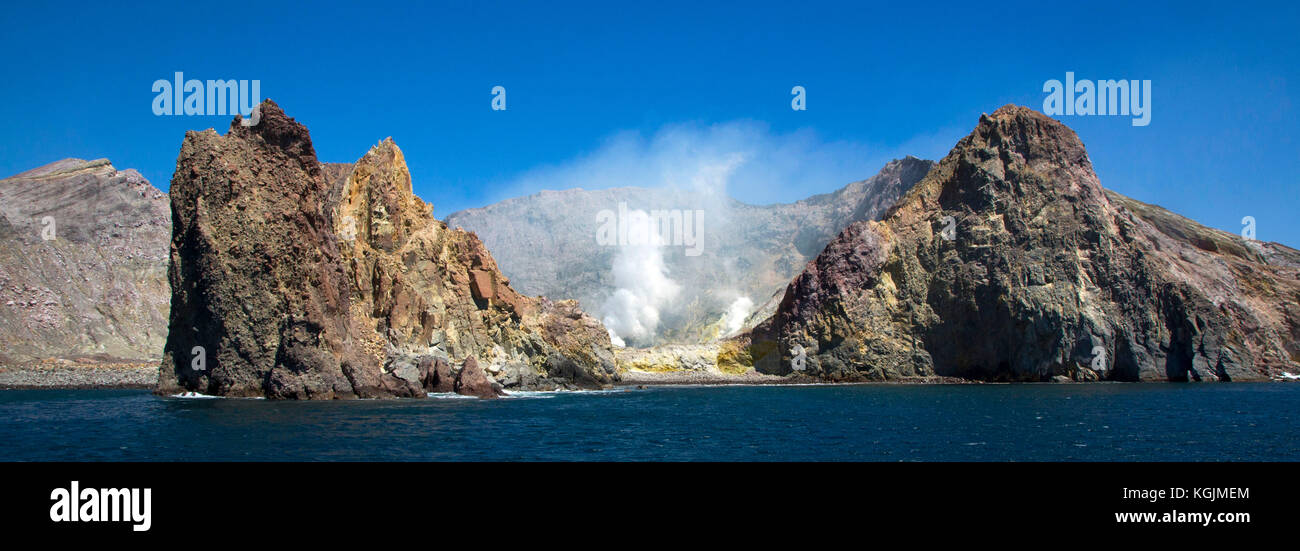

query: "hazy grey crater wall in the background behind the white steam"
left=446, top=157, right=933, bottom=346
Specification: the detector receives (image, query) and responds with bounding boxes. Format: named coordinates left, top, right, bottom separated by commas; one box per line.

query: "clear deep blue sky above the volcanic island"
left=0, top=1, right=1300, bottom=247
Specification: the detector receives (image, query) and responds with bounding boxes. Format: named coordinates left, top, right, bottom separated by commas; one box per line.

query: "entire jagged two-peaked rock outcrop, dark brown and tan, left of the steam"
left=159, top=101, right=615, bottom=399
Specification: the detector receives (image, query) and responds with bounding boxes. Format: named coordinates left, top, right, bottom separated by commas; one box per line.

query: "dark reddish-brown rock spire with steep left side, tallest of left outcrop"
left=159, top=101, right=379, bottom=399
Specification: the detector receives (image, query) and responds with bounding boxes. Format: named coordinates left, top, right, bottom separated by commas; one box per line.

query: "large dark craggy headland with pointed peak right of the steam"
left=746, top=105, right=1300, bottom=381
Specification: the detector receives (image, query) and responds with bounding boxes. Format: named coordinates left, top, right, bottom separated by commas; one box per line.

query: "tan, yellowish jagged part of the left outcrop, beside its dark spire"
left=333, top=135, right=615, bottom=387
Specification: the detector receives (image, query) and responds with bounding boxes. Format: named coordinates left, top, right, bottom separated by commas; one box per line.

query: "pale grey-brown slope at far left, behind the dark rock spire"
left=0, top=159, right=170, bottom=364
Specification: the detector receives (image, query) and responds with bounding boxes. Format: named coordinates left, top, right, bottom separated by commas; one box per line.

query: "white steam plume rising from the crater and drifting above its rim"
left=483, top=121, right=965, bottom=346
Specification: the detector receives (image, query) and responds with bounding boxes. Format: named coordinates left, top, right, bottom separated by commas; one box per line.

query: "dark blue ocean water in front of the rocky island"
left=0, top=383, right=1300, bottom=461
